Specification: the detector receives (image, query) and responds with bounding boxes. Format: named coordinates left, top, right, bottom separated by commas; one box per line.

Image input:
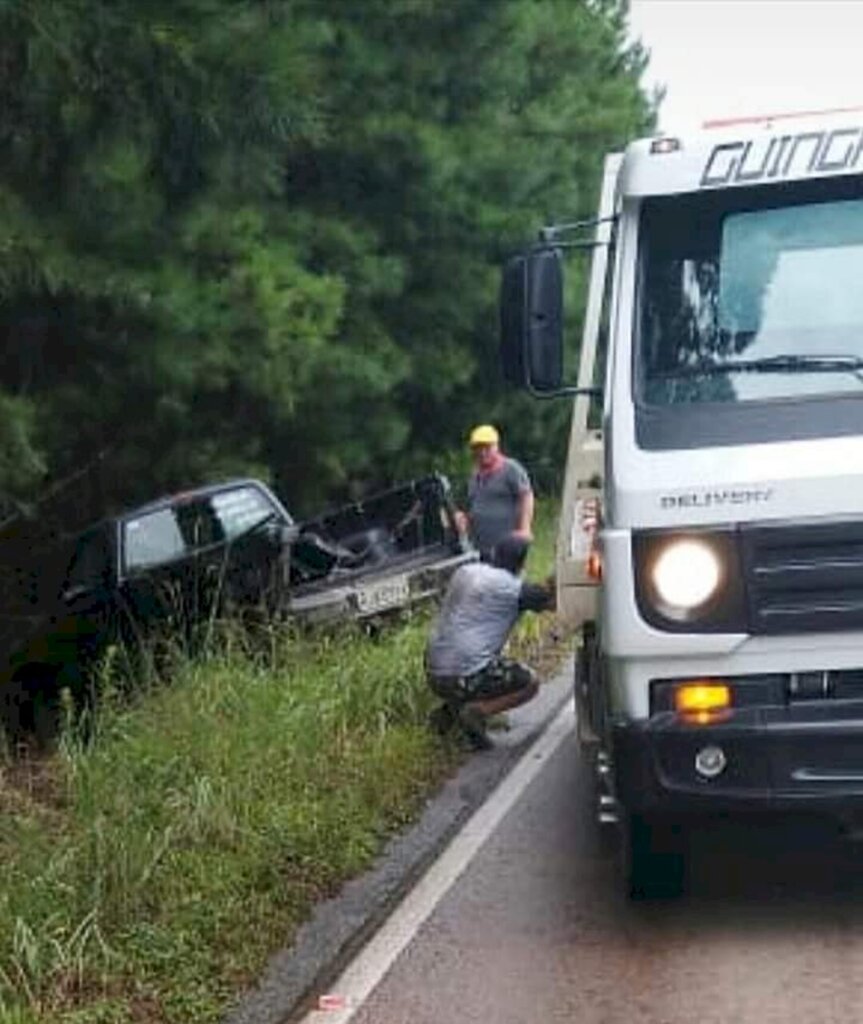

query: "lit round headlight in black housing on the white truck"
left=633, top=528, right=745, bottom=633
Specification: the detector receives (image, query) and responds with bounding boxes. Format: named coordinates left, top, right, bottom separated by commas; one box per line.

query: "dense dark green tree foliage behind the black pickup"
left=0, top=0, right=651, bottom=508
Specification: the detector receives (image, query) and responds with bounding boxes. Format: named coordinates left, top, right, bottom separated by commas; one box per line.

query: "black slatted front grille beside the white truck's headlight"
left=741, top=522, right=863, bottom=634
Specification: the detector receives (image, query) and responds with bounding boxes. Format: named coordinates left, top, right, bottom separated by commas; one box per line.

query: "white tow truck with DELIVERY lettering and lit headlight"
left=502, top=111, right=863, bottom=897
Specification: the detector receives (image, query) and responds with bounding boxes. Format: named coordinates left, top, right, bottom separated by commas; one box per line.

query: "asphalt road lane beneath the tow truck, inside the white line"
left=339, top=704, right=863, bottom=1024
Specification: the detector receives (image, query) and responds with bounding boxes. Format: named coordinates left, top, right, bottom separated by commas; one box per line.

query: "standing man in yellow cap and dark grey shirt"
left=460, top=423, right=533, bottom=560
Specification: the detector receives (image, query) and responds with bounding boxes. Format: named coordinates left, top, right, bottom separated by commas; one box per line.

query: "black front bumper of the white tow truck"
left=611, top=699, right=863, bottom=816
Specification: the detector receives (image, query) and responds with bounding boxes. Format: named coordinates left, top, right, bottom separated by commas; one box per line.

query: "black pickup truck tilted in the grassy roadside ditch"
left=0, top=476, right=477, bottom=735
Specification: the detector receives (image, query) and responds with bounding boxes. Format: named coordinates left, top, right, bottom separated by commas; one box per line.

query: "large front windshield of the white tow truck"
left=637, top=180, right=863, bottom=406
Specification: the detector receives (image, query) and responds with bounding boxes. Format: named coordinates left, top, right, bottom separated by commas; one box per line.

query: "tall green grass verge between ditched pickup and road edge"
left=0, top=499, right=554, bottom=1024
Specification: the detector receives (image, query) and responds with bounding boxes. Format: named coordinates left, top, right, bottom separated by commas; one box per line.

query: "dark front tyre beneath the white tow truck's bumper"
left=620, top=814, right=686, bottom=900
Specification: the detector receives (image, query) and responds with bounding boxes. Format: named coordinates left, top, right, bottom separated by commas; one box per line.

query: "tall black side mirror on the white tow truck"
left=501, top=249, right=563, bottom=394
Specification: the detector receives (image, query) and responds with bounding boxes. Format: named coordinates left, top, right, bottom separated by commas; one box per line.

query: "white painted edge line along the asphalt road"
left=302, top=700, right=574, bottom=1024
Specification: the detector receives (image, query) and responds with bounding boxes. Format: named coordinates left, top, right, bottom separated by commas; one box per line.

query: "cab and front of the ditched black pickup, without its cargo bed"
left=0, top=480, right=297, bottom=734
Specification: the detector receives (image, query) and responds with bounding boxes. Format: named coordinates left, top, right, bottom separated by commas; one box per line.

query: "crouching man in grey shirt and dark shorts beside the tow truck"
left=426, top=536, right=554, bottom=750
